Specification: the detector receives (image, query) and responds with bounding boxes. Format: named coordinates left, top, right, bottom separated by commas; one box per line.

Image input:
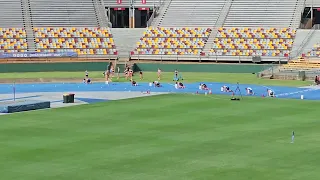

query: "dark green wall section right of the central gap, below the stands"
left=135, top=63, right=272, bottom=73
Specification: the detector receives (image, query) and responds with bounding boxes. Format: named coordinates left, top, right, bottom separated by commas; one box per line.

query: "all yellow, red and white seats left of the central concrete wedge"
left=0, top=27, right=117, bottom=54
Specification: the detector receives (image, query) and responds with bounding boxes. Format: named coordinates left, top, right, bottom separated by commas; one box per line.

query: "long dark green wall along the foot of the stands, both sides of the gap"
left=0, top=62, right=272, bottom=73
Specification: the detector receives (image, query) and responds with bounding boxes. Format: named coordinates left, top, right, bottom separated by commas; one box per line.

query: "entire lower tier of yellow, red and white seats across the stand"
left=0, top=27, right=300, bottom=56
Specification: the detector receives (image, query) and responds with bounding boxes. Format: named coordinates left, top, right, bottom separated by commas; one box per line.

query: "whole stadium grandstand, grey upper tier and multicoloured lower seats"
left=0, top=0, right=320, bottom=62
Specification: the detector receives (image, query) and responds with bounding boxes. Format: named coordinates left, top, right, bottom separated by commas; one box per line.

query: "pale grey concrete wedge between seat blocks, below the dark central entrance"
left=110, top=28, right=145, bottom=59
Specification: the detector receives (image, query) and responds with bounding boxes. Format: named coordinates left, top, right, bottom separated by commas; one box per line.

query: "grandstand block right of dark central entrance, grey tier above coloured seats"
left=131, top=0, right=305, bottom=62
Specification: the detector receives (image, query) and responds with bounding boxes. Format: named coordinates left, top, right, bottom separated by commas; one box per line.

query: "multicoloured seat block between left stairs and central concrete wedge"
left=34, top=27, right=117, bottom=55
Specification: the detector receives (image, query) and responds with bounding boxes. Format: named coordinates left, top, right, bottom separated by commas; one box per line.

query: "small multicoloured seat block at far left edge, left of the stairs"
left=0, top=28, right=28, bottom=53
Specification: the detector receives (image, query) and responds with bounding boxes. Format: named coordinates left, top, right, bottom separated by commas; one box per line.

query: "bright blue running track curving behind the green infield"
left=0, top=82, right=320, bottom=100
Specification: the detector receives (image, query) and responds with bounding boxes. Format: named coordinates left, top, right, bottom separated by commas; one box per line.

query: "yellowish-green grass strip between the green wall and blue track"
left=0, top=72, right=310, bottom=86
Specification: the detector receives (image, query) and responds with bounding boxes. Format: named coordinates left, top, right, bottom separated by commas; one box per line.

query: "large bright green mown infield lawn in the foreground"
left=0, top=94, right=320, bottom=180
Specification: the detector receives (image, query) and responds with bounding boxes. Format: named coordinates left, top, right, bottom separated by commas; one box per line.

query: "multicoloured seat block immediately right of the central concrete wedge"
left=135, top=27, right=211, bottom=55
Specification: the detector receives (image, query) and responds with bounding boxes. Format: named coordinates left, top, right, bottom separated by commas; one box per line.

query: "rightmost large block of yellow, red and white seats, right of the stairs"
left=210, top=28, right=296, bottom=56
